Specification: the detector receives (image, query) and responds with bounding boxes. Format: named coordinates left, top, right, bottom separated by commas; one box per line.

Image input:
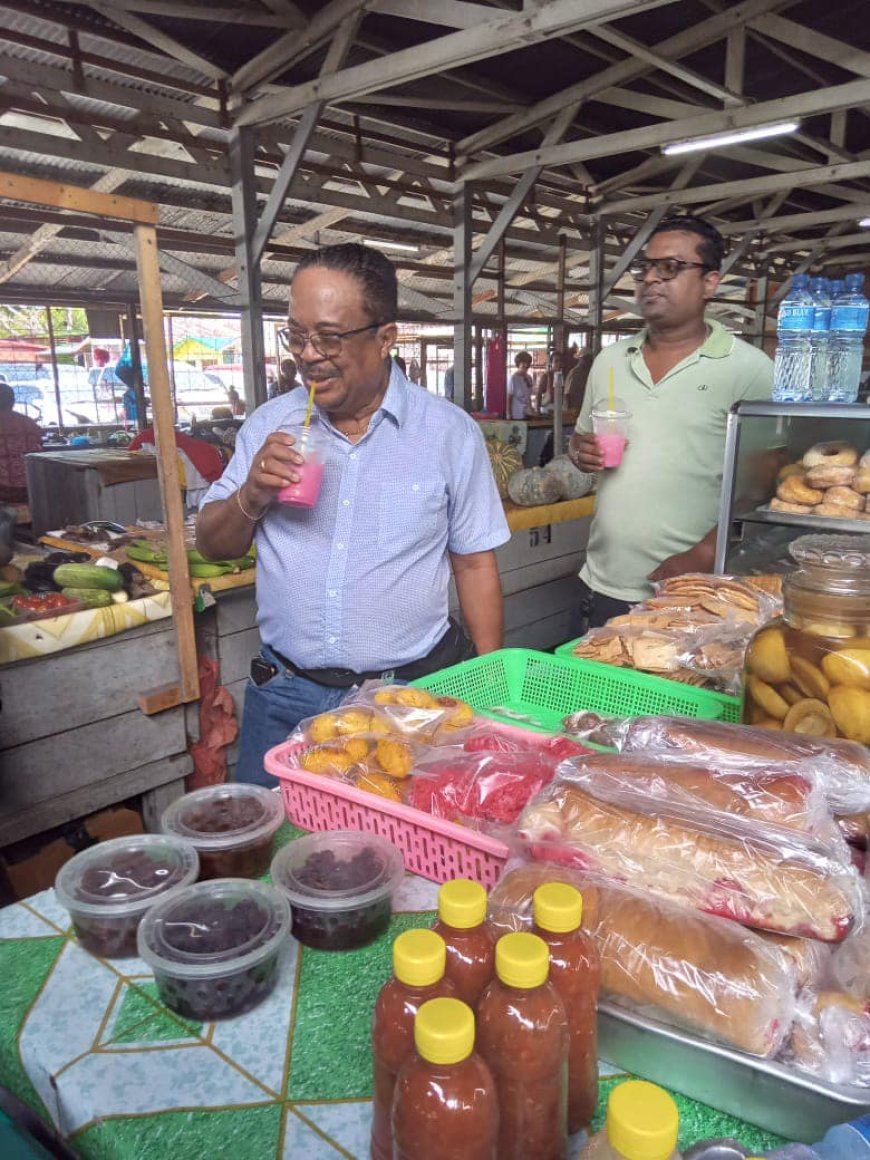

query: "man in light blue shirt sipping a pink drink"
left=196, top=244, right=510, bottom=784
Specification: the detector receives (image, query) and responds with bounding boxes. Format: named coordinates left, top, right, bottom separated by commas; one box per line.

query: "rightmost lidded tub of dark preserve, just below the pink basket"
left=271, top=829, right=405, bottom=950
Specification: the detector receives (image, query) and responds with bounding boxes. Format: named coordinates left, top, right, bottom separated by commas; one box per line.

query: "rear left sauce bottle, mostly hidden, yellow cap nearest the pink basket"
left=434, top=878, right=495, bottom=1007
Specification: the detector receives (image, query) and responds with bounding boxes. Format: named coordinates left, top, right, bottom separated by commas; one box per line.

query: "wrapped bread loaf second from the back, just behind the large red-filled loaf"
left=561, top=753, right=831, bottom=833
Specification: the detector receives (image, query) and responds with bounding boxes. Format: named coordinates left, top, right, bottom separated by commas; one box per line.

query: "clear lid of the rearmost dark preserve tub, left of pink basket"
left=160, top=782, right=284, bottom=851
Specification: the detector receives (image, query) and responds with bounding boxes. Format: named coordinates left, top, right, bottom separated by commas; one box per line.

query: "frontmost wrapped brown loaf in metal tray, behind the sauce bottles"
left=490, top=862, right=796, bottom=1057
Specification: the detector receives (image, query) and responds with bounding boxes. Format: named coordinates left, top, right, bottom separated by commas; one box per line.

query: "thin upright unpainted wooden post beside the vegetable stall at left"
left=133, top=225, right=200, bottom=700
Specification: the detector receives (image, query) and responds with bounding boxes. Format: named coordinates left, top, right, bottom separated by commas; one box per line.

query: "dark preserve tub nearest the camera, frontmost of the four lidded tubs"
left=139, top=878, right=290, bottom=1021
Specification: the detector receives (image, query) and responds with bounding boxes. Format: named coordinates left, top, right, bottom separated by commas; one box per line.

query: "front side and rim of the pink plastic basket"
left=266, top=741, right=508, bottom=889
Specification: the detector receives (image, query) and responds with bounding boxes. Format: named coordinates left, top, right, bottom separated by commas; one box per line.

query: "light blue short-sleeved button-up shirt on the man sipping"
left=203, top=363, right=510, bottom=673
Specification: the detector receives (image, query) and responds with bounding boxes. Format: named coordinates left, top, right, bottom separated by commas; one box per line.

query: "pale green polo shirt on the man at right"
left=575, top=318, right=774, bottom=602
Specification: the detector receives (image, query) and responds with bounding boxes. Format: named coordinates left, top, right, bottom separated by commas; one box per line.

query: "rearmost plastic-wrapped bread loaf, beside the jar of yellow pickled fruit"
left=607, top=717, right=870, bottom=814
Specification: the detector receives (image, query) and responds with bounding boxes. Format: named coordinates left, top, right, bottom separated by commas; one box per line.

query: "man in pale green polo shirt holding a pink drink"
left=570, top=216, right=774, bottom=626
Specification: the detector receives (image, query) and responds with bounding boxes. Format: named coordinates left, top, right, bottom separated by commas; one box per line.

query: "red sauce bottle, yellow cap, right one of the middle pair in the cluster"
left=477, top=934, right=568, bottom=1160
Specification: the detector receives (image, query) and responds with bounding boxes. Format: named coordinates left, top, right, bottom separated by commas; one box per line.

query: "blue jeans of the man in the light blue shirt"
left=235, top=645, right=353, bottom=789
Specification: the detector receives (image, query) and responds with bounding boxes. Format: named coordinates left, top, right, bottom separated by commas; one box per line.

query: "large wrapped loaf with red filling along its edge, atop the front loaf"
left=519, top=777, right=862, bottom=942
